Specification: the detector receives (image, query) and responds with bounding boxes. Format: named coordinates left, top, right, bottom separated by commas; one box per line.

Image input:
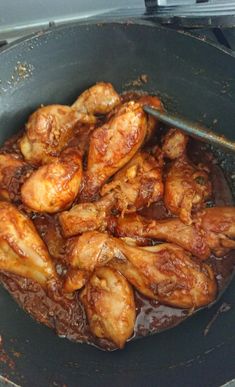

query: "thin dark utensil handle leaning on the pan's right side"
left=143, top=105, right=235, bottom=153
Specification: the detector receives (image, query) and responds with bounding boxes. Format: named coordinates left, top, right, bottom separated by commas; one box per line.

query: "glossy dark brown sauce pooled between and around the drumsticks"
left=0, top=106, right=235, bottom=350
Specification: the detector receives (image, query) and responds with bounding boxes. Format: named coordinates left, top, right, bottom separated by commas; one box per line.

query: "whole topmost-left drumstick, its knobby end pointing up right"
left=20, top=83, right=120, bottom=164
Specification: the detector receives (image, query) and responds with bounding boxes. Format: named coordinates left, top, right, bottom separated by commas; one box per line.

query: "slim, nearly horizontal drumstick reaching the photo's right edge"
left=108, top=207, right=235, bottom=260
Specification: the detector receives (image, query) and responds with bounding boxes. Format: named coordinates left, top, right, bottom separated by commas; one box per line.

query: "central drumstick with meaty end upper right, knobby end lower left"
left=59, top=152, right=163, bottom=237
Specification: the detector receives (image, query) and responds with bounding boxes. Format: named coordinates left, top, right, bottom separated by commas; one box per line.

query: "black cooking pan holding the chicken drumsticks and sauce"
left=0, top=22, right=235, bottom=387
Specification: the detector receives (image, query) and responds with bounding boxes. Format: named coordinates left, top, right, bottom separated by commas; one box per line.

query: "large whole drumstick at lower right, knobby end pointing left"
left=64, top=232, right=217, bottom=308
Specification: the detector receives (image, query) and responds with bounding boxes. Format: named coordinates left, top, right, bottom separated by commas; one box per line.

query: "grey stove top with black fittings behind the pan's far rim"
left=0, top=0, right=235, bottom=51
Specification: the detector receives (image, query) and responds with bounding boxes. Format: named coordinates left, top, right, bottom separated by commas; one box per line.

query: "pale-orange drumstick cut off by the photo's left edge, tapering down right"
left=0, top=202, right=57, bottom=287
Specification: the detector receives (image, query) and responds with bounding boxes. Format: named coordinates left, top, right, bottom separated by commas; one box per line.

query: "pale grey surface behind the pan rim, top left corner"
left=0, top=0, right=145, bottom=40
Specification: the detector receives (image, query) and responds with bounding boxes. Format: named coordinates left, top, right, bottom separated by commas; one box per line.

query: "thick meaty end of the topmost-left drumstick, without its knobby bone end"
left=19, top=105, right=78, bottom=164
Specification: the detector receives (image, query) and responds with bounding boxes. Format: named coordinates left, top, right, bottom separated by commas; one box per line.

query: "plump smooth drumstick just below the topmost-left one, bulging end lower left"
left=21, top=148, right=82, bottom=213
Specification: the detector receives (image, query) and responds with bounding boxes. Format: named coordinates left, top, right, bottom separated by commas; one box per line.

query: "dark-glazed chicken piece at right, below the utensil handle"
left=164, top=156, right=211, bottom=224
